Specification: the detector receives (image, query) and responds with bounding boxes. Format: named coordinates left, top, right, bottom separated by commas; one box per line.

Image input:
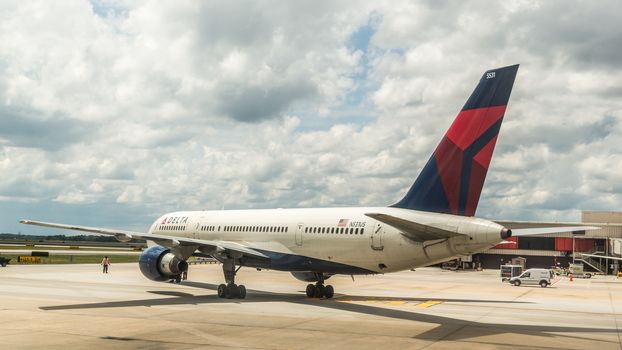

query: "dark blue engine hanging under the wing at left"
left=138, top=245, right=188, bottom=281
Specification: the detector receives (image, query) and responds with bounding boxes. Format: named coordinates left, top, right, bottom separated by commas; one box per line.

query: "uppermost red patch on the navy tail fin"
left=445, top=106, right=506, bottom=151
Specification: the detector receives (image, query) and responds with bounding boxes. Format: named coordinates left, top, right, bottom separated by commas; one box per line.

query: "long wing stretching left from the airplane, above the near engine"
left=19, top=220, right=270, bottom=259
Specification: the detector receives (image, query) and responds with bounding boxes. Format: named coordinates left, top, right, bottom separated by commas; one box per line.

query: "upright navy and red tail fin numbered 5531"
left=391, top=65, right=518, bottom=216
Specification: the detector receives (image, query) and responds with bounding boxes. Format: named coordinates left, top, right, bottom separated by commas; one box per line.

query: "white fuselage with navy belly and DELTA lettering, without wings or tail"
left=149, top=207, right=502, bottom=274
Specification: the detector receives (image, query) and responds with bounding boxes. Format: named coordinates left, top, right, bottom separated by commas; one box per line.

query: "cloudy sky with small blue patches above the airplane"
left=0, top=0, right=622, bottom=234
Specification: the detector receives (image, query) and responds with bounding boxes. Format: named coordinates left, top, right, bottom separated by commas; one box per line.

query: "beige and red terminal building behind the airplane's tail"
left=471, top=211, right=622, bottom=274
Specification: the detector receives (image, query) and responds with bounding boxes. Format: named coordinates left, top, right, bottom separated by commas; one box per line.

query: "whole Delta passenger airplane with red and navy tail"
left=20, top=65, right=591, bottom=299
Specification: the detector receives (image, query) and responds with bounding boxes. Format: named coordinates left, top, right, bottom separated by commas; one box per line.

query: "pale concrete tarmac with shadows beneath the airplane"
left=0, top=261, right=622, bottom=350
